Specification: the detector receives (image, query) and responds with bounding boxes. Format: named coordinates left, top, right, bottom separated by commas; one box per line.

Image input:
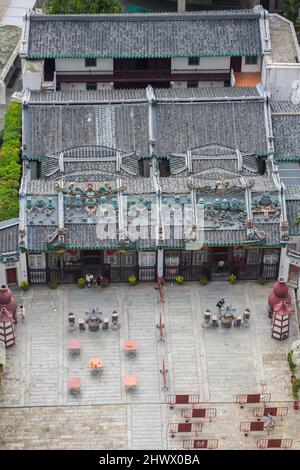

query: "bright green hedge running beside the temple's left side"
left=0, top=102, right=22, bottom=221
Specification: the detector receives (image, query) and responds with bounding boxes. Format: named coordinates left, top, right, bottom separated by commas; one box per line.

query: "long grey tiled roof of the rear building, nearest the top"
left=26, top=8, right=264, bottom=58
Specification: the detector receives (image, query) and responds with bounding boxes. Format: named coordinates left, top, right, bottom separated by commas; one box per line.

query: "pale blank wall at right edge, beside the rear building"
left=266, top=64, right=300, bottom=104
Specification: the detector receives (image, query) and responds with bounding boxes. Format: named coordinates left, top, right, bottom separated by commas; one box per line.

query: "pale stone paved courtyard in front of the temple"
left=0, top=282, right=300, bottom=449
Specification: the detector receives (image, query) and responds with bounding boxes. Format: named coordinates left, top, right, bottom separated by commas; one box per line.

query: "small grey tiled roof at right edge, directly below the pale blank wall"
left=272, top=101, right=300, bottom=159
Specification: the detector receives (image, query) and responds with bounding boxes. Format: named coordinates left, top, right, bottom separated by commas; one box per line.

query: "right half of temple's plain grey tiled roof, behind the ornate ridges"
left=156, top=101, right=267, bottom=155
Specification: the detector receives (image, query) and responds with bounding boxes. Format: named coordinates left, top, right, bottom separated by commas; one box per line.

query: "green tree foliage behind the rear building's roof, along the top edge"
left=46, top=0, right=121, bottom=15
